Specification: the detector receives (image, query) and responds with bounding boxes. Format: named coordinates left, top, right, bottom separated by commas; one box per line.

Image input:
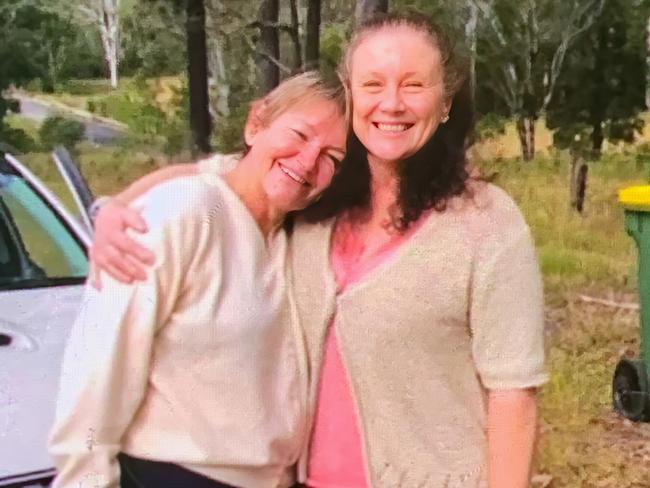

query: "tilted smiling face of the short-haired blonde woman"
left=246, top=98, right=346, bottom=212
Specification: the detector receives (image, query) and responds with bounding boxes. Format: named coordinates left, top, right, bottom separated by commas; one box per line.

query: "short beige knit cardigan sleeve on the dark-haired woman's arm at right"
left=470, top=195, right=547, bottom=389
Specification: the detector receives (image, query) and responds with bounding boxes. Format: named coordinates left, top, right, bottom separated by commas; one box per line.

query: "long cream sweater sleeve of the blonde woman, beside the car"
left=49, top=190, right=181, bottom=488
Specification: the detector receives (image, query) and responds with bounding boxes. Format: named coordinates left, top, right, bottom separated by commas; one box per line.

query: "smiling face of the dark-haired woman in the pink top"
left=349, top=26, right=450, bottom=163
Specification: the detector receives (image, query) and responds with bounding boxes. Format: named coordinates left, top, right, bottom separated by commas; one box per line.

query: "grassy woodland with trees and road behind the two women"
left=0, top=0, right=650, bottom=488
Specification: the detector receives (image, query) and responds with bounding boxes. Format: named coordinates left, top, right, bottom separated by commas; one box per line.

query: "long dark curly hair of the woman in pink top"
left=299, top=14, right=474, bottom=231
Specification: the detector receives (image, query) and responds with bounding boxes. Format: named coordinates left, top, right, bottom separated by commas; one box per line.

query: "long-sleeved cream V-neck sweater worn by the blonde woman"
left=50, top=169, right=306, bottom=488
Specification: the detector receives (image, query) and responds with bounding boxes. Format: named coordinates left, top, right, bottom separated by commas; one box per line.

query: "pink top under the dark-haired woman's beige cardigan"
left=307, top=212, right=428, bottom=488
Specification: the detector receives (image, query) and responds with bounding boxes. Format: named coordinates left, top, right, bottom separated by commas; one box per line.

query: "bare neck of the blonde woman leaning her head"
left=224, top=157, right=286, bottom=237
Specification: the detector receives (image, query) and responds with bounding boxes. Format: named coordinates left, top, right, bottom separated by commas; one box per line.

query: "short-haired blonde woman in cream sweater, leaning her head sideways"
left=50, top=73, right=346, bottom=488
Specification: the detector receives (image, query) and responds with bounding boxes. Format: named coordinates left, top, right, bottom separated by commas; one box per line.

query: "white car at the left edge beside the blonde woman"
left=0, top=152, right=92, bottom=487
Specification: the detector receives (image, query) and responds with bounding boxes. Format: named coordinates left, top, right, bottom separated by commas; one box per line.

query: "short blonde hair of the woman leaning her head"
left=258, top=71, right=349, bottom=127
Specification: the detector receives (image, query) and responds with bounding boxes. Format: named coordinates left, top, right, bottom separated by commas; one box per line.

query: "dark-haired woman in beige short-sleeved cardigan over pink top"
left=88, top=12, right=546, bottom=488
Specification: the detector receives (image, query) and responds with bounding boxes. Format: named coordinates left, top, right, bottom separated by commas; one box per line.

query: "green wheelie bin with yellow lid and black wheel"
left=612, top=185, right=650, bottom=422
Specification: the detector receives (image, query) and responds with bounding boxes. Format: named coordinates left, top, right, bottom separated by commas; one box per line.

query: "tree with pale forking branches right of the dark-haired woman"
left=469, top=0, right=605, bottom=160
